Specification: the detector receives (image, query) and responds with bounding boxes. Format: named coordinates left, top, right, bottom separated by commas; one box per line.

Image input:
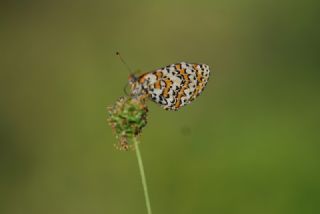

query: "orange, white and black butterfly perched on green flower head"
left=129, top=62, right=210, bottom=110
